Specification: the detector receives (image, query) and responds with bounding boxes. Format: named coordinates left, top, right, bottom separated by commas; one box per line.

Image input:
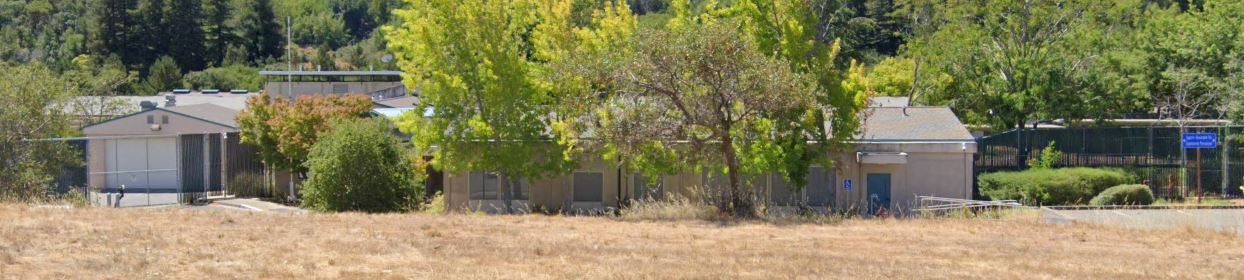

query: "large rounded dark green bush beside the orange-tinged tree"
left=302, top=119, right=423, bottom=213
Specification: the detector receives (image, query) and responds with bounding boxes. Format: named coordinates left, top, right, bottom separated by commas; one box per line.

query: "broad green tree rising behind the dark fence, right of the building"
left=906, top=0, right=1131, bottom=128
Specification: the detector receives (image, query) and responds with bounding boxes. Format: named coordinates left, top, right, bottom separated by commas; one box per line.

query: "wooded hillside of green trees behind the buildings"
left=0, top=0, right=1244, bottom=128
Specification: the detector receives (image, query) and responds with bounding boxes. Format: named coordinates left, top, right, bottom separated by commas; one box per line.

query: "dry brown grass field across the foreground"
left=0, top=204, right=1244, bottom=279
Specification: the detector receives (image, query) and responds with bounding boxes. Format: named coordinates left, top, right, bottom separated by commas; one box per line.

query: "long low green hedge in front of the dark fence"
left=977, top=168, right=1136, bottom=205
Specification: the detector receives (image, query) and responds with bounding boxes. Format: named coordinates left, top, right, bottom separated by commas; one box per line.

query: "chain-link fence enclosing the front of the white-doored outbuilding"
left=55, top=133, right=264, bottom=207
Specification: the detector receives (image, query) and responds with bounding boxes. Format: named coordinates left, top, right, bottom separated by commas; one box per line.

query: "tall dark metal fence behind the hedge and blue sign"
left=975, top=126, right=1244, bottom=198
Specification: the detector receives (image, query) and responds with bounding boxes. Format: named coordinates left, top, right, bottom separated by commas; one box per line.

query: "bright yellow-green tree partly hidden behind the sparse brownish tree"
left=711, top=0, right=873, bottom=203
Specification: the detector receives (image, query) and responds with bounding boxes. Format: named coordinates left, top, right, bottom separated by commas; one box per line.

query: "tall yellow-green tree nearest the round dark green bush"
left=384, top=0, right=573, bottom=212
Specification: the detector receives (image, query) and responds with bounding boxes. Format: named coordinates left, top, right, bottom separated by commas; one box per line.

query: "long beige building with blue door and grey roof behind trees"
left=444, top=102, right=977, bottom=213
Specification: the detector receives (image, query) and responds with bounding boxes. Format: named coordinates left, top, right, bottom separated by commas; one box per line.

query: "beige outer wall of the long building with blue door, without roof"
left=444, top=142, right=975, bottom=212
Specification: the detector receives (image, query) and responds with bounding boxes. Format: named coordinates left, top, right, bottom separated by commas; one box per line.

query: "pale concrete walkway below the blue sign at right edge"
left=1041, top=208, right=1244, bottom=235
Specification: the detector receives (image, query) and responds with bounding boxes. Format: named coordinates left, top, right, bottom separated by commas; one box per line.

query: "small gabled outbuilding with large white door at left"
left=82, top=102, right=261, bottom=203
